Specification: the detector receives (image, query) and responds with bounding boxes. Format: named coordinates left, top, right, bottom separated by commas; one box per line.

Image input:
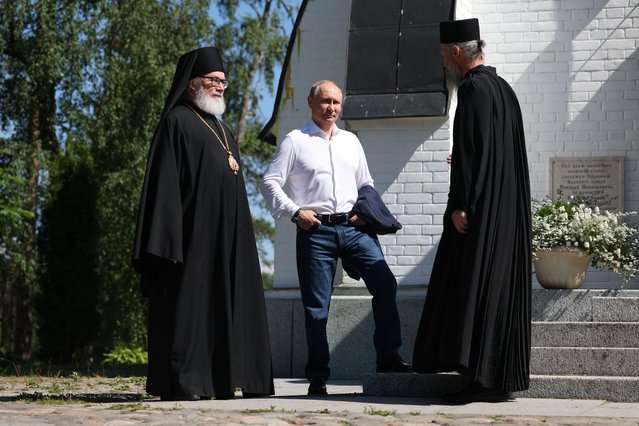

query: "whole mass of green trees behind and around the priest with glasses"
left=0, top=0, right=293, bottom=361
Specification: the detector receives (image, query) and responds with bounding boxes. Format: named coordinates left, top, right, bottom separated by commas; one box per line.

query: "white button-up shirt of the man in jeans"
left=260, top=120, right=373, bottom=218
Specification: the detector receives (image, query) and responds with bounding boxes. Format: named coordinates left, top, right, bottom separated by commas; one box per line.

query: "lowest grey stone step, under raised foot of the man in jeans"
left=362, top=373, right=639, bottom=402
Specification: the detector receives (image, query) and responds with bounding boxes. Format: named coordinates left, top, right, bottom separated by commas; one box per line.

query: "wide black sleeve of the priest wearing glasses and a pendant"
left=133, top=117, right=183, bottom=272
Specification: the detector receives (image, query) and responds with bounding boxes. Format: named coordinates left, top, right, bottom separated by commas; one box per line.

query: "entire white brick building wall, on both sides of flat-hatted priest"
left=275, top=0, right=639, bottom=288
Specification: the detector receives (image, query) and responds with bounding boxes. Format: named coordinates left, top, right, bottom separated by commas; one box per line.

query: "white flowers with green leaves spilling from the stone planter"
left=532, top=198, right=639, bottom=283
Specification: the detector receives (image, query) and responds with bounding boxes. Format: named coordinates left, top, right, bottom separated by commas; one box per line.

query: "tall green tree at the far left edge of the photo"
left=0, top=0, right=99, bottom=360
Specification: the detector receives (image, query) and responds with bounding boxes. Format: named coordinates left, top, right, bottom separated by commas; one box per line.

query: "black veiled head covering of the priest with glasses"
left=162, top=47, right=224, bottom=117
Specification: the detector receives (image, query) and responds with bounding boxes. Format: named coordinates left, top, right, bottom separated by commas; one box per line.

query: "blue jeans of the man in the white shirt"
left=296, top=222, right=402, bottom=381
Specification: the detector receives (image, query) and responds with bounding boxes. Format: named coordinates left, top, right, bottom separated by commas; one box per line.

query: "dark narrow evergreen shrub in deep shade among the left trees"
left=35, top=145, right=99, bottom=362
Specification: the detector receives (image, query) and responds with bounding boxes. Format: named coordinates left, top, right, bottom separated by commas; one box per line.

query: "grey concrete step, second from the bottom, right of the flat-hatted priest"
left=530, top=347, right=639, bottom=377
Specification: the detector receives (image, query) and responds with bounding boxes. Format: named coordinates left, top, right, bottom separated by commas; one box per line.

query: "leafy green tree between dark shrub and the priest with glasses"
left=87, top=0, right=213, bottom=351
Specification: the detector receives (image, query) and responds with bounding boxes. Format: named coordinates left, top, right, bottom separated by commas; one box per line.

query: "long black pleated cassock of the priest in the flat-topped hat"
left=413, top=65, right=531, bottom=391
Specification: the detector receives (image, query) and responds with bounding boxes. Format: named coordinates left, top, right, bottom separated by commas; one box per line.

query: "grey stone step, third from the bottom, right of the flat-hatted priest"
left=531, top=321, right=639, bottom=348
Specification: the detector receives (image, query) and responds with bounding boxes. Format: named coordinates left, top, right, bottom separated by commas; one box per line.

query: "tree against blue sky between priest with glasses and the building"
left=215, top=0, right=297, bottom=270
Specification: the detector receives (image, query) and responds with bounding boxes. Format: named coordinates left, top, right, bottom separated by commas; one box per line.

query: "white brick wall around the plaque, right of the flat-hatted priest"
left=472, top=0, right=639, bottom=288
